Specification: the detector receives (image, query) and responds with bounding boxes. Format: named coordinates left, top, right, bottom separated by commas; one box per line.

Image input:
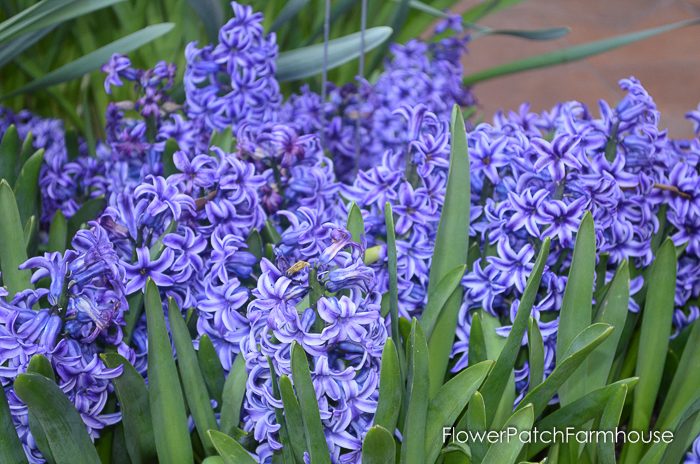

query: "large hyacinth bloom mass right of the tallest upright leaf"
left=453, top=78, right=700, bottom=400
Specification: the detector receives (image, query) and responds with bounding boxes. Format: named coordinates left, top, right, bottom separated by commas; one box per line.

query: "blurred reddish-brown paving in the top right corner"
left=459, top=0, right=700, bottom=137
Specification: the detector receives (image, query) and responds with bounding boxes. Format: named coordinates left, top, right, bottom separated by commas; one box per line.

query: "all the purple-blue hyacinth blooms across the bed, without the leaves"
left=0, top=2, right=700, bottom=462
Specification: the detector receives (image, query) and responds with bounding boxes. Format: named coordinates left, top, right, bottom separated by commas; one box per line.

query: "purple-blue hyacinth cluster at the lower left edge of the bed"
left=0, top=224, right=126, bottom=463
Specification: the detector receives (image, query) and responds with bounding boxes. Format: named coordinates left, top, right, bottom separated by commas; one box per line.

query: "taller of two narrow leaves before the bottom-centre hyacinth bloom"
left=292, top=342, right=331, bottom=464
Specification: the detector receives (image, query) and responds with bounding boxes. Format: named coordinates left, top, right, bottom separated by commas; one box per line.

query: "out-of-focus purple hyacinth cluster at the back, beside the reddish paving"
left=279, top=17, right=474, bottom=183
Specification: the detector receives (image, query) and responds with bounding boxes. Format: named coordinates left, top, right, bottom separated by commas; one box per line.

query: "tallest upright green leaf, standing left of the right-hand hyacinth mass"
left=423, top=105, right=471, bottom=396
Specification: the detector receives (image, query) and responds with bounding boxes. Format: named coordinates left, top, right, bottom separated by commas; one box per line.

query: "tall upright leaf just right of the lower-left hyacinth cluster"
left=146, top=279, right=194, bottom=464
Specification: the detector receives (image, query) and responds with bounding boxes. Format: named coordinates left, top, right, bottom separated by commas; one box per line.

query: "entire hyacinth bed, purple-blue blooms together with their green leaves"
left=0, top=3, right=700, bottom=463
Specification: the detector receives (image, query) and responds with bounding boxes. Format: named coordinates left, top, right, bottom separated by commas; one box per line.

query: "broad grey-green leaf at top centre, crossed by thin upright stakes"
left=277, top=26, right=392, bottom=82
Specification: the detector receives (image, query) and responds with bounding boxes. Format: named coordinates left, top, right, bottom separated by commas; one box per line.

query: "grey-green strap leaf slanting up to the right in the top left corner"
left=0, top=23, right=174, bottom=99
